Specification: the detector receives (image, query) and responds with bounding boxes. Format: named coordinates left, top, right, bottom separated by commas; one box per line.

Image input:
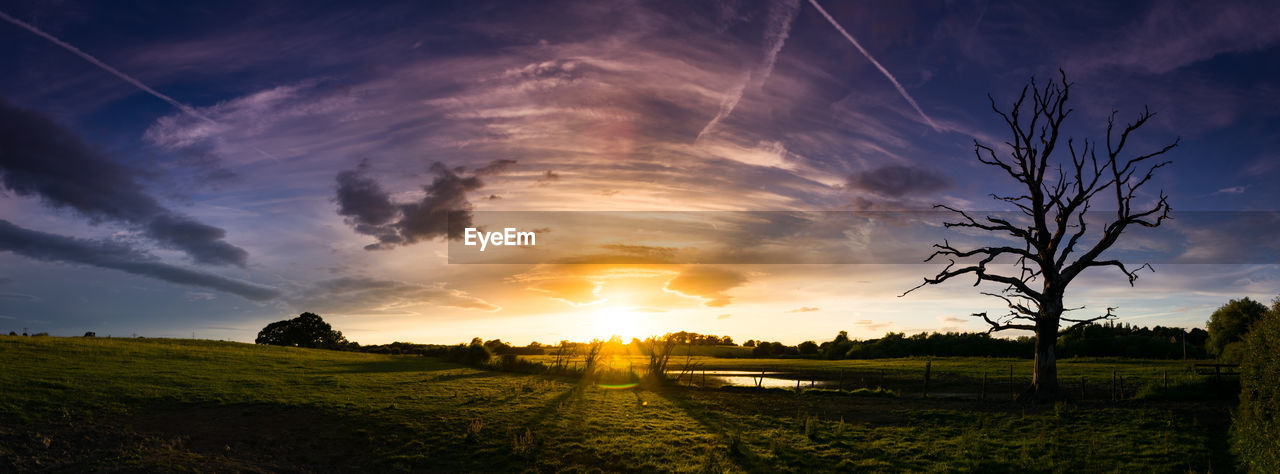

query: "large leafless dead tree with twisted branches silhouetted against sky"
left=902, top=70, right=1179, bottom=398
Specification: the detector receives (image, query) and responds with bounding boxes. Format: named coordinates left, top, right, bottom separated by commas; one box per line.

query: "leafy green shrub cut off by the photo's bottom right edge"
left=1231, top=303, right=1280, bottom=473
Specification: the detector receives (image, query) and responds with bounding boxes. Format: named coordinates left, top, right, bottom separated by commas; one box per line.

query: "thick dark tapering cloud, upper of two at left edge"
left=0, top=99, right=248, bottom=266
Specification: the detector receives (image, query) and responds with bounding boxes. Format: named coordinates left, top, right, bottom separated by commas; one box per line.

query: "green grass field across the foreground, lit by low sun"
left=0, top=337, right=1231, bottom=471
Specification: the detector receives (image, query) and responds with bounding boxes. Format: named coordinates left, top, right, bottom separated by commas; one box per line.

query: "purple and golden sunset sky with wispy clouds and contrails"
left=0, top=0, right=1280, bottom=343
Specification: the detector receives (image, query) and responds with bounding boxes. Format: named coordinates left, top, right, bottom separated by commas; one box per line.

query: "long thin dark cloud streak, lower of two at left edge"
left=0, top=219, right=276, bottom=301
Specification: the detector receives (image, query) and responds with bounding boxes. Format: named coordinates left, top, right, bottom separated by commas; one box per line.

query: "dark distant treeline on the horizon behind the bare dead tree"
left=745, top=322, right=1208, bottom=359
